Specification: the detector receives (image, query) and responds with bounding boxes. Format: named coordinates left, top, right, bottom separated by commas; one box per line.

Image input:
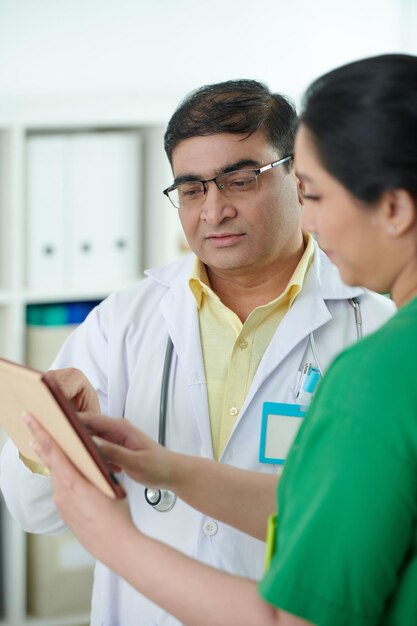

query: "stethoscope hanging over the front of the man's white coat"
left=145, top=298, right=362, bottom=513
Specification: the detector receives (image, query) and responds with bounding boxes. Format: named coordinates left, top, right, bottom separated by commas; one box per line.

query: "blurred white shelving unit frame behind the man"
left=0, top=96, right=184, bottom=626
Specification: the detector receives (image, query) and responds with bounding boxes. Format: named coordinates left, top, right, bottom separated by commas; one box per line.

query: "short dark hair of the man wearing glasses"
left=164, top=79, right=297, bottom=169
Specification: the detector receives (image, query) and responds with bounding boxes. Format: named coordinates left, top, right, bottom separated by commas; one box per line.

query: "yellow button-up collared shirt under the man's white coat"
left=189, top=235, right=314, bottom=459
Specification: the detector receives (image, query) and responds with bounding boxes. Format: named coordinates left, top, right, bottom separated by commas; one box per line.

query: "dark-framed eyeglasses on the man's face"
left=163, top=154, right=293, bottom=209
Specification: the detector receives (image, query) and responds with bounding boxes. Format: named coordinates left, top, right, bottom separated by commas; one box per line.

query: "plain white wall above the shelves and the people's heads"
left=0, top=0, right=417, bottom=109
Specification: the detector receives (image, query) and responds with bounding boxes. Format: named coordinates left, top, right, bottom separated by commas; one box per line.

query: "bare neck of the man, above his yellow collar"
left=206, top=242, right=305, bottom=323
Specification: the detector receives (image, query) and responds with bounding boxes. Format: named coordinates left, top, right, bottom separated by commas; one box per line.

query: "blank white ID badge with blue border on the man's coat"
left=259, top=402, right=305, bottom=465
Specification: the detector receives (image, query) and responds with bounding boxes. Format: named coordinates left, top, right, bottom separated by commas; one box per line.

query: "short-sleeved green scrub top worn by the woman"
left=259, top=299, right=417, bottom=626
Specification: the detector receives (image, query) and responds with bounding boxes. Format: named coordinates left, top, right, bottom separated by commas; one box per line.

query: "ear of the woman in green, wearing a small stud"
left=380, top=189, right=417, bottom=235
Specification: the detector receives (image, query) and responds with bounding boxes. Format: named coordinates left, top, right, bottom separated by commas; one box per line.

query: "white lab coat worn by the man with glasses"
left=0, top=243, right=394, bottom=626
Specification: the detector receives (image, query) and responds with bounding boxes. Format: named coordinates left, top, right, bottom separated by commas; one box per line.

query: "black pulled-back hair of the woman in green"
left=300, top=54, right=417, bottom=203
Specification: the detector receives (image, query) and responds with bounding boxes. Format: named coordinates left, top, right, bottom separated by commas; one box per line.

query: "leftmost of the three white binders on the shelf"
left=26, top=136, right=69, bottom=289
